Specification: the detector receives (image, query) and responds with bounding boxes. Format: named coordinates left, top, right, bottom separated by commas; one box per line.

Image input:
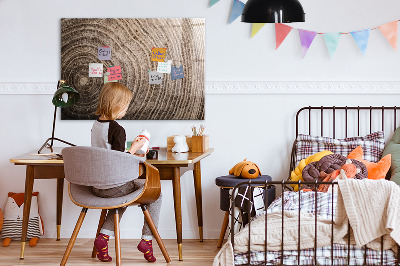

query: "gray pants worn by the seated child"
left=93, top=180, right=162, bottom=240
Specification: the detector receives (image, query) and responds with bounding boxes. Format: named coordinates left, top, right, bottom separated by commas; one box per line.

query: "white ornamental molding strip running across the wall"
left=0, top=81, right=400, bottom=94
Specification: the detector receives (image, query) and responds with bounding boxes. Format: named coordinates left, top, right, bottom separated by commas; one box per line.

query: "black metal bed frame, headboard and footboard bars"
left=230, top=106, right=400, bottom=265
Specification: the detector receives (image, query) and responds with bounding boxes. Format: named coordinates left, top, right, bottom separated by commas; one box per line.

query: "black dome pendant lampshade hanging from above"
left=242, top=0, right=304, bottom=23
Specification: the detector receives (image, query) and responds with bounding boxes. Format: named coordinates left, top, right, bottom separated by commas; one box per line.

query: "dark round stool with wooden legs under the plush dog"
left=215, top=175, right=275, bottom=248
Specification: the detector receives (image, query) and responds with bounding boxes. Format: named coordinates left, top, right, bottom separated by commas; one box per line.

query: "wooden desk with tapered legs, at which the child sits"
left=10, top=148, right=214, bottom=260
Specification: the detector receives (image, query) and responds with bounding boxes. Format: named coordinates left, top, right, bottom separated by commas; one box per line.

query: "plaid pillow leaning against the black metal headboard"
left=295, top=131, right=385, bottom=165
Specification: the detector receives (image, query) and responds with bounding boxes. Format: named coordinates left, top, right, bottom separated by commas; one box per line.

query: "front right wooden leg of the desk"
left=172, top=167, right=182, bottom=261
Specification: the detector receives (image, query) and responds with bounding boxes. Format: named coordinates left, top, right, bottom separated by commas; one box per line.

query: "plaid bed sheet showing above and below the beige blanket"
left=235, top=191, right=396, bottom=265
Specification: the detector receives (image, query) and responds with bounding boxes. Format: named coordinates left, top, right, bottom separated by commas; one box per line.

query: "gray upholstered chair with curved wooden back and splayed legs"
left=60, top=146, right=171, bottom=265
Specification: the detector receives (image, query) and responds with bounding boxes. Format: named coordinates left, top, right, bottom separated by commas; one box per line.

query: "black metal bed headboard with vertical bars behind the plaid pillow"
left=289, top=106, right=400, bottom=179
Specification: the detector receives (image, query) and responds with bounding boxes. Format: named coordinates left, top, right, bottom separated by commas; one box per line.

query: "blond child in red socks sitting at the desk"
left=91, top=82, right=161, bottom=262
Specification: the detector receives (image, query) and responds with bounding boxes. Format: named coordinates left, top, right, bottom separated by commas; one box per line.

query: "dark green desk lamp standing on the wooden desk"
left=38, top=80, right=80, bottom=153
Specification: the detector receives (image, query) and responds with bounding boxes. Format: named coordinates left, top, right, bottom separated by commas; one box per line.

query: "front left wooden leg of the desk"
left=20, top=165, right=34, bottom=260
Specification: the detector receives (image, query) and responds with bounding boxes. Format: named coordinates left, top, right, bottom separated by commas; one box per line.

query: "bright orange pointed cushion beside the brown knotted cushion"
left=347, top=146, right=392, bottom=180
